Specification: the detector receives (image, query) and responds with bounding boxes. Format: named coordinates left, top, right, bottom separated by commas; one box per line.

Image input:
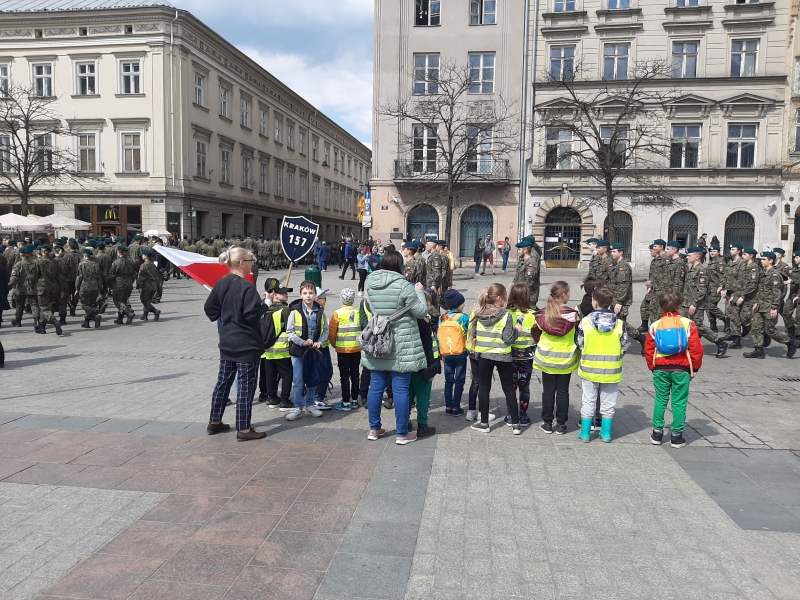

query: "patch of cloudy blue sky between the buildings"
left=170, top=0, right=373, bottom=144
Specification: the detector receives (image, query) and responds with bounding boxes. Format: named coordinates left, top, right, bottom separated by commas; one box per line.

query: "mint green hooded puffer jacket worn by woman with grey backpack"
left=361, top=270, right=428, bottom=373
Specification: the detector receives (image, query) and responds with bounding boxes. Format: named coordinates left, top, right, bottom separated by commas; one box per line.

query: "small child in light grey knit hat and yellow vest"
left=328, top=288, right=361, bottom=410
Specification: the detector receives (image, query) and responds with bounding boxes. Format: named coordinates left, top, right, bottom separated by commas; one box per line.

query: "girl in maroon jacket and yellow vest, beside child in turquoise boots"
left=531, top=281, right=580, bottom=435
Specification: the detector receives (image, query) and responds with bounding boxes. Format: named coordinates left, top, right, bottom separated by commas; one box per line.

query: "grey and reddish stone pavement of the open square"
left=0, top=270, right=800, bottom=600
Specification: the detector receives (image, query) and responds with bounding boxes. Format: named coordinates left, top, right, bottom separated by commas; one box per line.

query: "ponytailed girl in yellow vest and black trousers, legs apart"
left=467, top=283, right=522, bottom=435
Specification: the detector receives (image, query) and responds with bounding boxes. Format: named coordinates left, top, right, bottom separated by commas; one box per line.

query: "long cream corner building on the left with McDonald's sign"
left=0, top=0, right=371, bottom=240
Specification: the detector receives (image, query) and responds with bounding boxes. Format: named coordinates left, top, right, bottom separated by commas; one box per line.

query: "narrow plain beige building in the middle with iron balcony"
left=367, top=0, right=525, bottom=256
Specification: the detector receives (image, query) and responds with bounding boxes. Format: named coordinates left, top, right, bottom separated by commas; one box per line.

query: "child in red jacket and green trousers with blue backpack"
left=644, top=292, right=703, bottom=448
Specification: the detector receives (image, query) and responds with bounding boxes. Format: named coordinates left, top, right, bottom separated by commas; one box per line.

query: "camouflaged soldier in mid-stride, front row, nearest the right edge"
left=744, top=252, right=797, bottom=358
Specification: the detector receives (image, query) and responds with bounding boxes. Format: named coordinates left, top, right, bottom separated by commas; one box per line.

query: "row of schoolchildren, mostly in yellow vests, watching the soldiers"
left=250, top=270, right=703, bottom=448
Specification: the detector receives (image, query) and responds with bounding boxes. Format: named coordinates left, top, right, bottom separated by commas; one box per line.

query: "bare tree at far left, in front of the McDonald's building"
left=0, top=85, right=86, bottom=215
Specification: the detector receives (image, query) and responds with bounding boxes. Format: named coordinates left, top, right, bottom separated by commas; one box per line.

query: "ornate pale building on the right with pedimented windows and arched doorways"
left=525, top=0, right=800, bottom=268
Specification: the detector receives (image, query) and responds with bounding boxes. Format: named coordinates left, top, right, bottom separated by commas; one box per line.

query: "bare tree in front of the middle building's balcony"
left=378, top=61, right=519, bottom=239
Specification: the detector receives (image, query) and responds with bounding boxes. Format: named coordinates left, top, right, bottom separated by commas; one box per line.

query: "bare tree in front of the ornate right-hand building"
left=533, top=60, right=689, bottom=242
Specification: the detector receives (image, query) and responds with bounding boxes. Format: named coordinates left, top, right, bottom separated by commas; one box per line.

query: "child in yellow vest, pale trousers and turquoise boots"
left=577, top=286, right=628, bottom=442
